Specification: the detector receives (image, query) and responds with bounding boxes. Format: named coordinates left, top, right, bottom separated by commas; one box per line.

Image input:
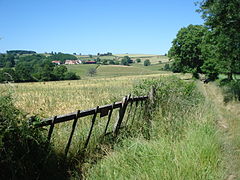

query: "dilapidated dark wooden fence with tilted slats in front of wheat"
left=35, top=93, right=151, bottom=156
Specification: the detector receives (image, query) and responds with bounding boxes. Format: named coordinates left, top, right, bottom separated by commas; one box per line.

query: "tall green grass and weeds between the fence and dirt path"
left=86, top=77, right=225, bottom=180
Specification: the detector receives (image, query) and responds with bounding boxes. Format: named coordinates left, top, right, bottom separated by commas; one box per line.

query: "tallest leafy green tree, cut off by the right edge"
left=199, top=0, right=240, bottom=79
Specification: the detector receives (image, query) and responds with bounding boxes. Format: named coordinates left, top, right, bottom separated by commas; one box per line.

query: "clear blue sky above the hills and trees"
left=0, top=0, right=203, bottom=54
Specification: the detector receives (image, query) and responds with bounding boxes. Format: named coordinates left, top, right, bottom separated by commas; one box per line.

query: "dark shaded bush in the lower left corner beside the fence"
left=0, top=96, right=65, bottom=179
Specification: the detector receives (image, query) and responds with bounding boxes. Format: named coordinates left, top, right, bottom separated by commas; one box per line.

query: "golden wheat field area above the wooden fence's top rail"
left=0, top=74, right=168, bottom=117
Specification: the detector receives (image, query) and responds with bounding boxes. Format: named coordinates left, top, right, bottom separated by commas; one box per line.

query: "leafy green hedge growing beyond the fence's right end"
left=134, top=76, right=202, bottom=121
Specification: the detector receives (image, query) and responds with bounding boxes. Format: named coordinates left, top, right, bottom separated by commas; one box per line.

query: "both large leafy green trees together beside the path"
left=168, top=0, right=240, bottom=80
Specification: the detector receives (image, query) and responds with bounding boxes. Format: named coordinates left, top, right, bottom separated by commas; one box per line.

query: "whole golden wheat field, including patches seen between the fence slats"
left=0, top=73, right=191, bottom=153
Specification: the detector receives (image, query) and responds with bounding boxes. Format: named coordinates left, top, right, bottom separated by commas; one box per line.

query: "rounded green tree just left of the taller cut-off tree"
left=168, top=25, right=207, bottom=74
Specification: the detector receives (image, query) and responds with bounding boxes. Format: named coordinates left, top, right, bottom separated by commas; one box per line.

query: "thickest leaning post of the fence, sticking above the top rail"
left=113, top=95, right=131, bottom=136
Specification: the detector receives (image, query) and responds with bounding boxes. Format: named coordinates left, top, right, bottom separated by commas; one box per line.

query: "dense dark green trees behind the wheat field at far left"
left=0, top=54, right=80, bottom=82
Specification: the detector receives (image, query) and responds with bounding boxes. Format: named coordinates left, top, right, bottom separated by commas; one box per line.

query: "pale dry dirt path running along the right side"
left=198, top=82, right=240, bottom=180
